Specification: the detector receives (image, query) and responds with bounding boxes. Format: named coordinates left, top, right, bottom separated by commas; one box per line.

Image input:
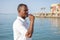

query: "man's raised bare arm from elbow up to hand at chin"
left=26, top=14, right=34, bottom=38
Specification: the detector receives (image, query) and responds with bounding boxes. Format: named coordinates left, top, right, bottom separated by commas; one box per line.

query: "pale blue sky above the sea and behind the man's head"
left=0, top=0, right=60, bottom=14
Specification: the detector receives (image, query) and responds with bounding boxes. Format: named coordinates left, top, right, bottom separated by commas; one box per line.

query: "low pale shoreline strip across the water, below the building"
left=34, top=13, right=60, bottom=18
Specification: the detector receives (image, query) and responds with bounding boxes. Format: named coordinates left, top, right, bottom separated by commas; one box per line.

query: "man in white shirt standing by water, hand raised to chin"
left=13, top=4, right=34, bottom=40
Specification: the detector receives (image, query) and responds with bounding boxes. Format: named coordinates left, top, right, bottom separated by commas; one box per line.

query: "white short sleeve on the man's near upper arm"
left=13, top=23, right=27, bottom=34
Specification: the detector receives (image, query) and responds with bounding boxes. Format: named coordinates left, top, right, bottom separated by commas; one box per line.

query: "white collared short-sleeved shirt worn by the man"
left=13, top=16, right=31, bottom=40
